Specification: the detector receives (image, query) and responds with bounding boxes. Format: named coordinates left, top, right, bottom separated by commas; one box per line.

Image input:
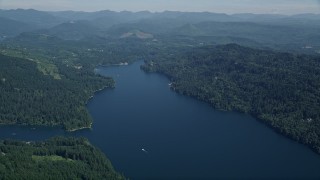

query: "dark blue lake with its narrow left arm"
left=0, top=62, right=320, bottom=179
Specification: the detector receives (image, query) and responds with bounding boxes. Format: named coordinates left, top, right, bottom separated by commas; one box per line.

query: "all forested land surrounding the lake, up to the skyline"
left=0, top=9, right=320, bottom=177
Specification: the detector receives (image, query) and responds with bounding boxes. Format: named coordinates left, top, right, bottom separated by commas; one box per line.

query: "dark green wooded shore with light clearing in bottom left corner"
left=0, top=137, right=125, bottom=180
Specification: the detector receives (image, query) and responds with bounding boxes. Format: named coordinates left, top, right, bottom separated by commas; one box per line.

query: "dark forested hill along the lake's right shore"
left=142, top=44, right=320, bottom=153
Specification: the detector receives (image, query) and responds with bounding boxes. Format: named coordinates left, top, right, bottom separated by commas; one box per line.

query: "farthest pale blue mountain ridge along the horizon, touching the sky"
left=0, top=9, right=320, bottom=31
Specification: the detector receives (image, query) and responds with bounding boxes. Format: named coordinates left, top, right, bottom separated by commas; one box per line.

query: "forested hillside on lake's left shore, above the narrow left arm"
left=0, top=52, right=114, bottom=130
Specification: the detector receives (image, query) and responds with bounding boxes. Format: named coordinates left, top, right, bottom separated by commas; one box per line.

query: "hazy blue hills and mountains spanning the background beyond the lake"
left=0, top=9, right=320, bottom=52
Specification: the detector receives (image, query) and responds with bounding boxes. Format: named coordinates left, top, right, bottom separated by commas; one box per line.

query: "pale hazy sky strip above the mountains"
left=0, top=0, right=320, bottom=14
